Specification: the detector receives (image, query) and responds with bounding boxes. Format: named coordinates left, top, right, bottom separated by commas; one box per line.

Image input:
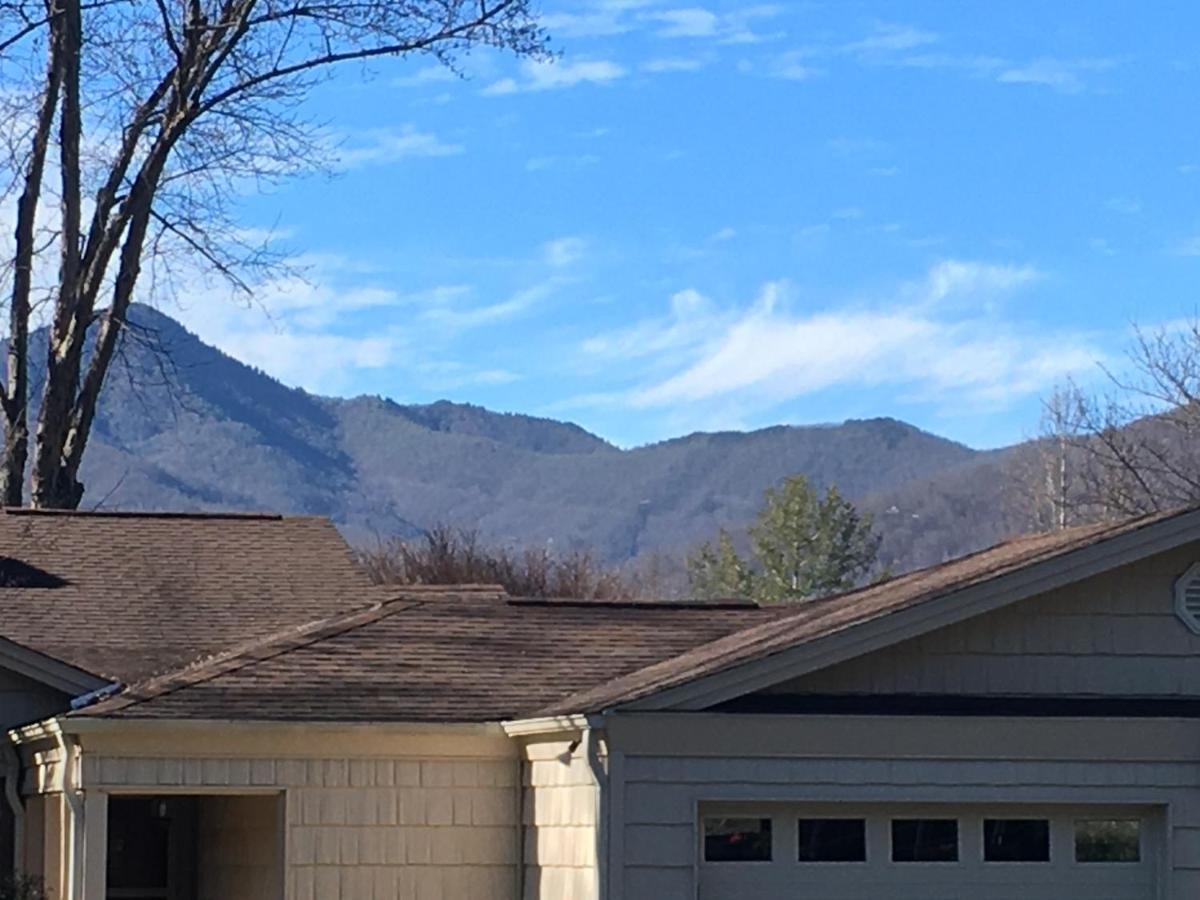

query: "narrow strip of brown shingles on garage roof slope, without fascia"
left=538, top=509, right=1196, bottom=715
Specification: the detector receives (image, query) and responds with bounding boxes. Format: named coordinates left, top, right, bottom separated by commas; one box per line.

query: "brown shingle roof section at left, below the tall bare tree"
left=0, top=510, right=374, bottom=682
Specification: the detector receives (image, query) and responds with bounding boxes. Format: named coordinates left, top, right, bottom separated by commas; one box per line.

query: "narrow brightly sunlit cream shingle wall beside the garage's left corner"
left=523, top=740, right=600, bottom=900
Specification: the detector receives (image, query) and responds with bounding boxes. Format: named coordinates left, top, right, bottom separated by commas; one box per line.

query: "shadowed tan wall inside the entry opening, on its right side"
left=197, top=796, right=283, bottom=900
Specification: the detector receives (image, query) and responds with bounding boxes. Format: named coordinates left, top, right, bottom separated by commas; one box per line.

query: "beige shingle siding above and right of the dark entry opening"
left=84, top=754, right=520, bottom=900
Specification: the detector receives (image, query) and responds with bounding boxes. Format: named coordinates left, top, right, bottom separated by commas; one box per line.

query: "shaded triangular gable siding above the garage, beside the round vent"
left=770, top=545, right=1200, bottom=696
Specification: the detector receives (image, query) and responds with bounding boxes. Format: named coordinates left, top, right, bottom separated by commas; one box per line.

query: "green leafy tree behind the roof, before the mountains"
left=688, top=475, right=880, bottom=604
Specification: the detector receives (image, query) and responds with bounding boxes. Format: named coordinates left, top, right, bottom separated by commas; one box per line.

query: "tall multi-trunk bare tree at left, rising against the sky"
left=0, top=0, right=545, bottom=508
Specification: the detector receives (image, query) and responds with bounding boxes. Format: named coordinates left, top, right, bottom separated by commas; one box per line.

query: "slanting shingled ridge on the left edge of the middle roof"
left=79, top=596, right=421, bottom=715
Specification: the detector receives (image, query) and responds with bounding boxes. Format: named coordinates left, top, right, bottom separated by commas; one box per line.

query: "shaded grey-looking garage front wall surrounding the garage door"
left=607, top=714, right=1200, bottom=900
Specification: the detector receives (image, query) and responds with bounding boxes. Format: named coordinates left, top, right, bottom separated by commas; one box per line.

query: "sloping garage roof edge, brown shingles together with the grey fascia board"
left=539, top=509, right=1200, bottom=715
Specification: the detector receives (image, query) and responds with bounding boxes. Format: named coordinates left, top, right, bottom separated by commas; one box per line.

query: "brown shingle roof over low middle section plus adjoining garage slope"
left=72, top=510, right=1195, bottom=721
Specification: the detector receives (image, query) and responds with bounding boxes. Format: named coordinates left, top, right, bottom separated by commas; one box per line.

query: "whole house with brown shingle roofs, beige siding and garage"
left=0, top=510, right=1200, bottom=900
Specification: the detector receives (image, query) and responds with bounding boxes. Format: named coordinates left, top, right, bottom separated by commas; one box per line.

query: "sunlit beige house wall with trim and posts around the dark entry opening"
left=15, top=726, right=521, bottom=900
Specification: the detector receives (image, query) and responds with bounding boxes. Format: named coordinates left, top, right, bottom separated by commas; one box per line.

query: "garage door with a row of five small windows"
left=697, top=804, right=1162, bottom=900
